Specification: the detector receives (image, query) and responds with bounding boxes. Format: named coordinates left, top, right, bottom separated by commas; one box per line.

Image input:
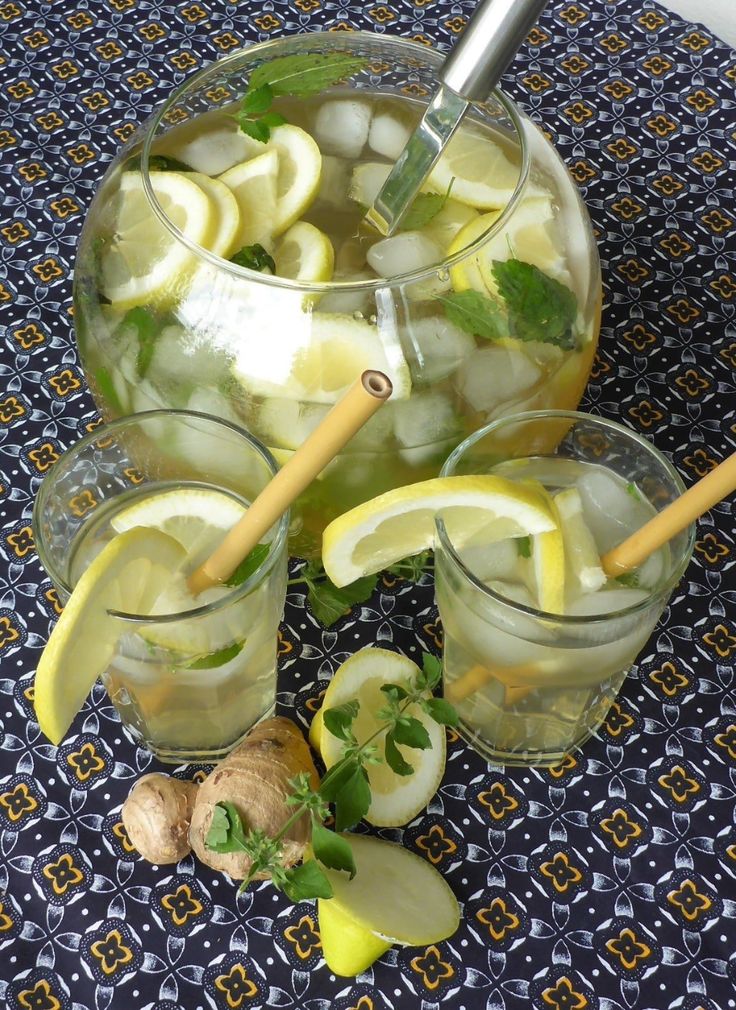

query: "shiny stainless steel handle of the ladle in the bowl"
left=439, top=0, right=548, bottom=101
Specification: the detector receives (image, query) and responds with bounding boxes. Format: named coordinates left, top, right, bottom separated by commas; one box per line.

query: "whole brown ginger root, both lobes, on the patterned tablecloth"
left=122, top=716, right=319, bottom=880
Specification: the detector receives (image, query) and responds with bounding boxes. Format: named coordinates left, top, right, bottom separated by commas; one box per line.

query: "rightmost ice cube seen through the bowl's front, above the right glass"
left=456, top=347, right=542, bottom=413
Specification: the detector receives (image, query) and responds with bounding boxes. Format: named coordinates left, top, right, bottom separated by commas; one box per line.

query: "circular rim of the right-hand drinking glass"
left=435, top=410, right=696, bottom=627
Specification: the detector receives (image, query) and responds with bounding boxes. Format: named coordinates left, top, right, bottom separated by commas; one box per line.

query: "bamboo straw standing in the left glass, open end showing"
left=187, top=370, right=393, bottom=596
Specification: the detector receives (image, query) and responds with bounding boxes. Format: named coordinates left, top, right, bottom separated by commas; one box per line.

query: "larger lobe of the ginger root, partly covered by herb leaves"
left=189, top=716, right=319, bottom=880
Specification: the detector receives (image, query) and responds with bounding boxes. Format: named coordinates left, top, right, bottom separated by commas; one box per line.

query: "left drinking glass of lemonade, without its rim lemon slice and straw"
left=33, top=411, right=289, bottom=763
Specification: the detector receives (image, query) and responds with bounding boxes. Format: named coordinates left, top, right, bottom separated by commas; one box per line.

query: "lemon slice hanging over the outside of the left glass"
left=34, top=528, right=186, bottom=744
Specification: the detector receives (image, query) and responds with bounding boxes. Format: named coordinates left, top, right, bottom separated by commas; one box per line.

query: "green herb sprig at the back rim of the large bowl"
left=235, top=53, right=367, bottom=143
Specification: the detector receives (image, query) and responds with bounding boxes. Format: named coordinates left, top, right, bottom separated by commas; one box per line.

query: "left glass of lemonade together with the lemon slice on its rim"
left=34, top=414, right=288, bottom=763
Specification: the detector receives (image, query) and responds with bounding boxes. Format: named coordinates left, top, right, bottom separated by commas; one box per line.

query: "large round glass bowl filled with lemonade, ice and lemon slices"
left=75, top=32, right=601, bottom=556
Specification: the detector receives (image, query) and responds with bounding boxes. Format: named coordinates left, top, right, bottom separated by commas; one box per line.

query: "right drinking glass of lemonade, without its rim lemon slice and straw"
left=435, top=411, right=695, bottom=766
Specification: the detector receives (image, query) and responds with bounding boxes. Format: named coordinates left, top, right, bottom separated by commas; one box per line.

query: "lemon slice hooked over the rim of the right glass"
left=322, top=475, right=556, bottom=586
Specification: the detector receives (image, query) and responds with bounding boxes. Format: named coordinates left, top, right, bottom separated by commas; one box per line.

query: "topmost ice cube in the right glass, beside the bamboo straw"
left=577, top=467, right=654, bottom=554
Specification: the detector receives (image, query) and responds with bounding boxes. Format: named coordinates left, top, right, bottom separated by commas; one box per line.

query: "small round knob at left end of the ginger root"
left=122, top=772, right=199, bottom=865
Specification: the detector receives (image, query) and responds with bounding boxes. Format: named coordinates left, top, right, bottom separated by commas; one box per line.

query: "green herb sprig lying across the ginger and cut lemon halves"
left=206, top=653, right=457, bottom=902
